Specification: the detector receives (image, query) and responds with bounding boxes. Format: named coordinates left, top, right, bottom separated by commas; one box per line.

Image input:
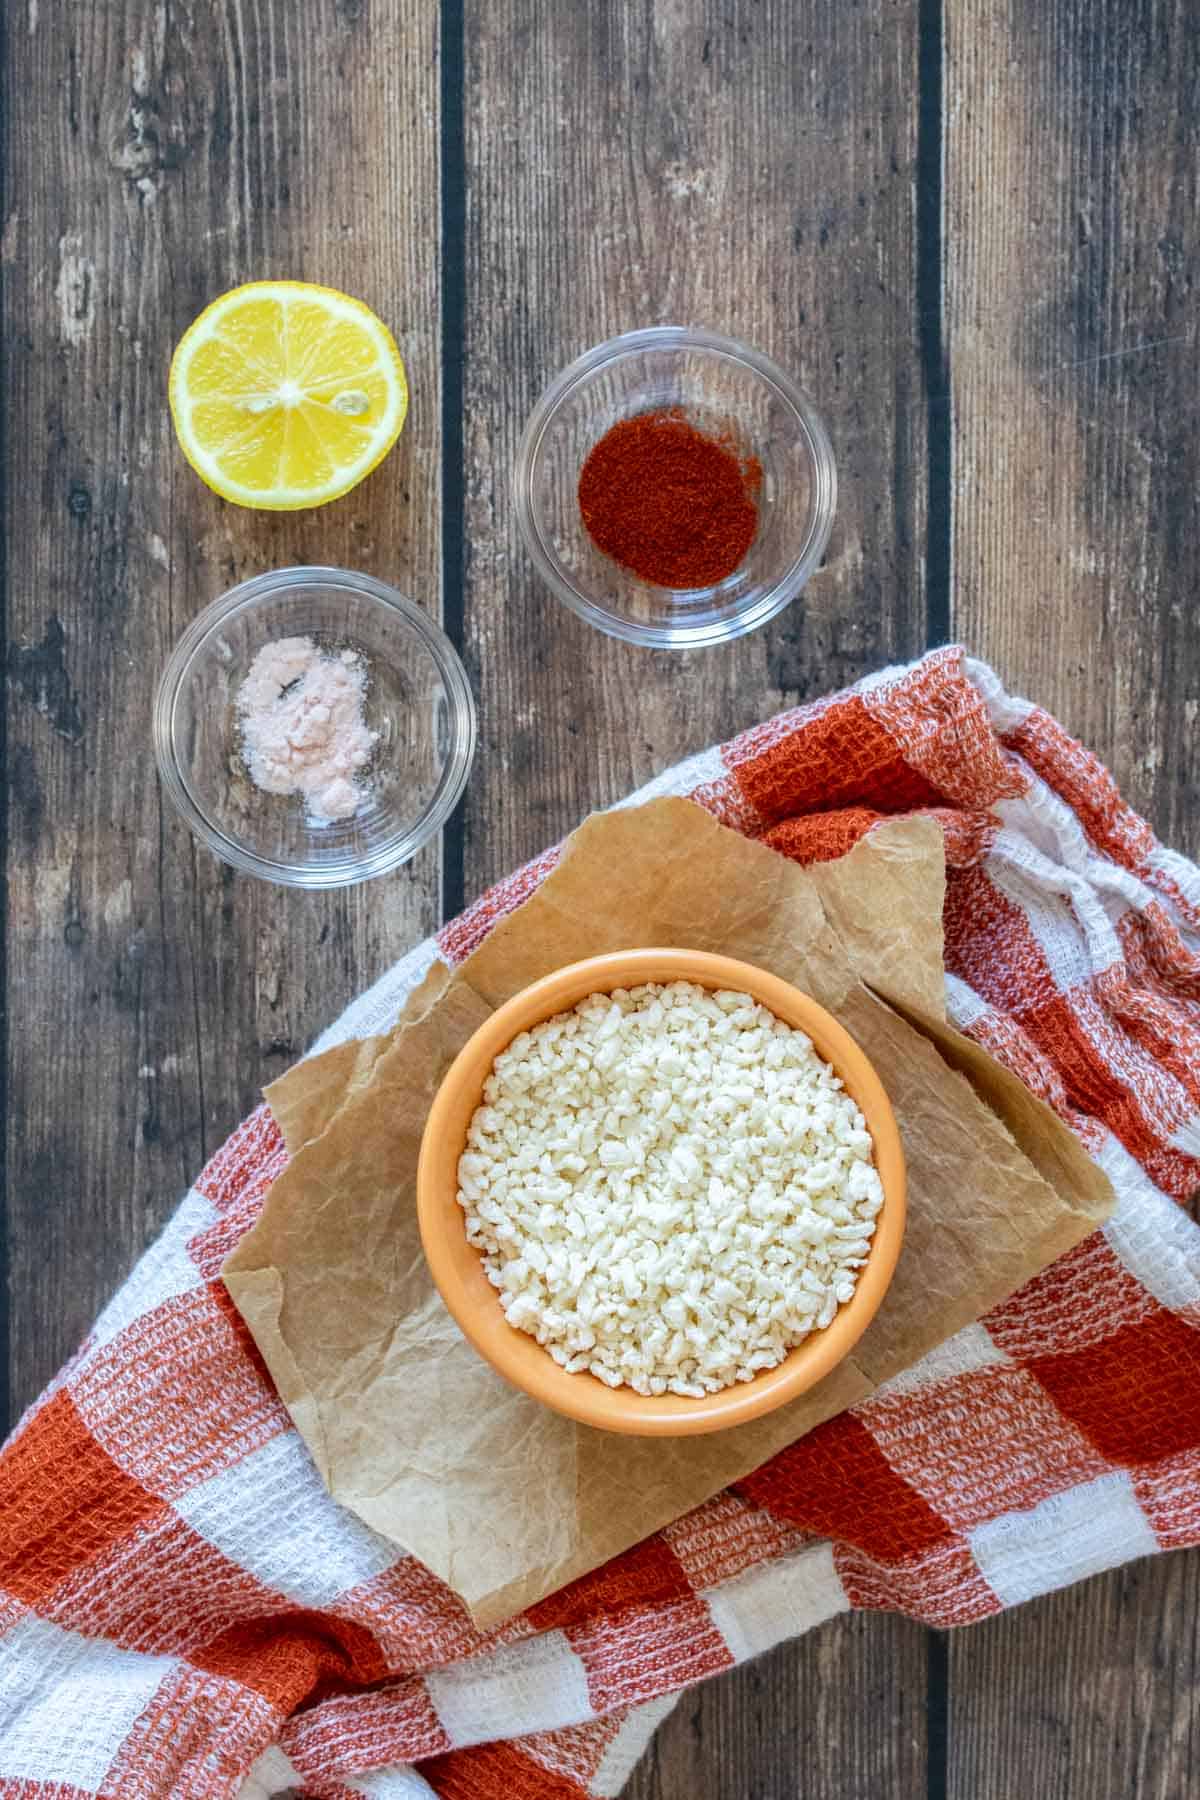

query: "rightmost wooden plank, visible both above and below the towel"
left=945, top=0, right=1200, bottom=1800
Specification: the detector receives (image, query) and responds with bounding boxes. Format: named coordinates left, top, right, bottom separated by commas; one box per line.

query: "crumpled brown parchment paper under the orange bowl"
left=225, top=799, right=1112, bottom=1625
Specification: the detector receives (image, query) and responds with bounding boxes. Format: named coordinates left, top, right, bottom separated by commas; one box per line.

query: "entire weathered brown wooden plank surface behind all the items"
left=0, top=0, right=1200, bottom=1800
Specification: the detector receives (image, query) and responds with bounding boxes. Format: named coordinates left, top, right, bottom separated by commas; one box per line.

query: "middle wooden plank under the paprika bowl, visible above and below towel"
left=464, top=0, right=927, bottom=1800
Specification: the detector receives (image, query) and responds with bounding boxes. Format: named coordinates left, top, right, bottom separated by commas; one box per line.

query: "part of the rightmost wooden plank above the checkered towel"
left=945, top=0, right=1200, bottom=851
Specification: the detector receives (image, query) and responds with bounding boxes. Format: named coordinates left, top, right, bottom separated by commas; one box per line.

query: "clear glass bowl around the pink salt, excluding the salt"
left=155, top=569, right=475, bottom=887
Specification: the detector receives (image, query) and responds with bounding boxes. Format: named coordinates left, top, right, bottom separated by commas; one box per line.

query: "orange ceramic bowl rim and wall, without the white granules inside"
left=417, top=950, right=905, bottom=1438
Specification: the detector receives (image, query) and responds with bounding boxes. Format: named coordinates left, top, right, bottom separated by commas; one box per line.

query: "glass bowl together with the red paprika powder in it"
left=515, top=326, right=837, bottom=648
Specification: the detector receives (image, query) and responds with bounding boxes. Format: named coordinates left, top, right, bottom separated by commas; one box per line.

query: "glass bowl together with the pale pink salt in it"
left=155, top=569, right=475, bottom=887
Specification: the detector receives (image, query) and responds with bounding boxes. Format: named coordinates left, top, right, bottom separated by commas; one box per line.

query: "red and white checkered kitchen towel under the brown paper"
left=0, top=650, right=1200, bottom=1800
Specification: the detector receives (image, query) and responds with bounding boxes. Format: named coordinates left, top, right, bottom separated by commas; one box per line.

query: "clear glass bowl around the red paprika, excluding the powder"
left=515, top=326, right=837, bottom=648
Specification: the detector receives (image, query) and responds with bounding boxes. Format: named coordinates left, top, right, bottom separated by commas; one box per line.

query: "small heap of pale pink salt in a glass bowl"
left=237, top=637, right=378, bottom=824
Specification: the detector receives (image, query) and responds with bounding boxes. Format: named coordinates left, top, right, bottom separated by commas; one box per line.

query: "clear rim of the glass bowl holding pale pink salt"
left=153, top=563, right=479, bottom=889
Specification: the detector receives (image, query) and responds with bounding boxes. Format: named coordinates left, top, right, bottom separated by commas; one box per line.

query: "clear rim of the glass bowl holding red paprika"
left=513, top=324, right=838, bottom=650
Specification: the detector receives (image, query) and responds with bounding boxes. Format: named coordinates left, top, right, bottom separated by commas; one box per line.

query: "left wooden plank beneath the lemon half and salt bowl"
left=4, top=0, right=441, bottom=1409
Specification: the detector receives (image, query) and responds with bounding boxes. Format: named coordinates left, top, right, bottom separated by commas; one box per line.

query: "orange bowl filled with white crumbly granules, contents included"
left=417, top=949, right=905, bottom=1436
